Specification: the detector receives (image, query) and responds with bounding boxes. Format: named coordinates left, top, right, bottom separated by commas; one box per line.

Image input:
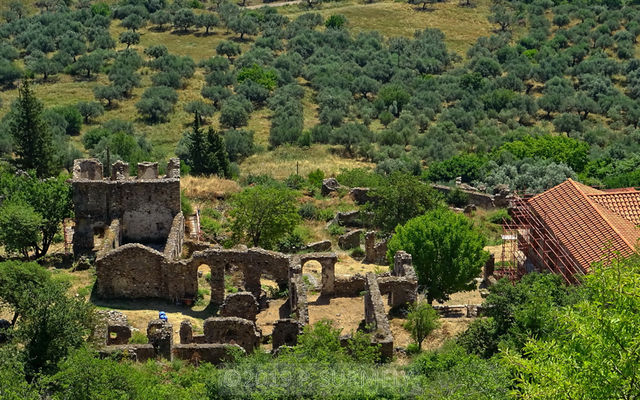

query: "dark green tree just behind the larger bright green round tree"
left=367, top=172, right=439, bottom=232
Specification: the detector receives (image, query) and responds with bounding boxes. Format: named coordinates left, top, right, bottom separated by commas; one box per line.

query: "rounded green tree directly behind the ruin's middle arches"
left=229, top=186, right=300, bottom=249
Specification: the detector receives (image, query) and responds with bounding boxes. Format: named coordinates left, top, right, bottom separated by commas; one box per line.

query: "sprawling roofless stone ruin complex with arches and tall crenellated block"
left=72, top=159, right=417, bottom=363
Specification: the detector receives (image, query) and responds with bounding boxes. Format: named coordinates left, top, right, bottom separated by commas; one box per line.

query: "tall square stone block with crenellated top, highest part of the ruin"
left=71, top=159, right=180, bottom=255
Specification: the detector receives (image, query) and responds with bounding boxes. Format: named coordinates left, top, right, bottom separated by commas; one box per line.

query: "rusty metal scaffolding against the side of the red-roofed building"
left=496, top=195, right=584, bottom=283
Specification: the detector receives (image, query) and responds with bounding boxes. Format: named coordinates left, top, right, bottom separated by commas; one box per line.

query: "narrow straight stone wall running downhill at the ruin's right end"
left=364, top=272, right=393, bottom=359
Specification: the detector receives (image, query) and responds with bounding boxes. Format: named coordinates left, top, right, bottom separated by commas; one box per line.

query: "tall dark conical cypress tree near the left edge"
left=9, top=80, right=54, bottom=177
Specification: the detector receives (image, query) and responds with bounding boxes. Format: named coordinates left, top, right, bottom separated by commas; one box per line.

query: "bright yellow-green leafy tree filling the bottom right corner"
left=506, top=256, right=640, bottom=399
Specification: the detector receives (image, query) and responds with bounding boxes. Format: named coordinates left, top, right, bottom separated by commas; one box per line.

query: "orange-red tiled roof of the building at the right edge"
left=528, top=179, right=640, bottom=271
